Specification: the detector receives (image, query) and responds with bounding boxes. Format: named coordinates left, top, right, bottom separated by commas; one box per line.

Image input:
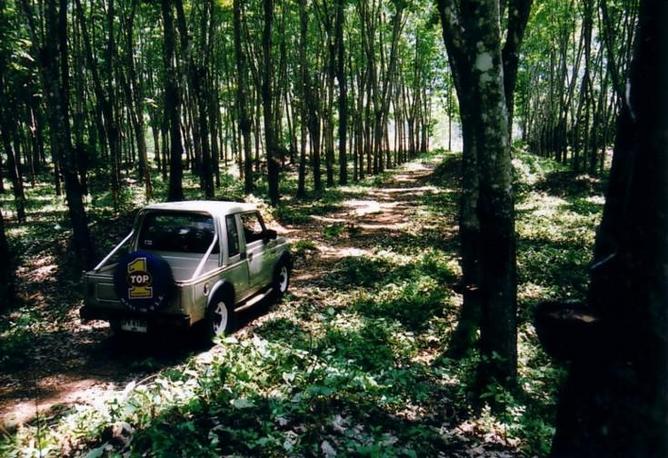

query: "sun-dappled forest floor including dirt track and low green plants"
left=0, top=153, right=603, bottom=456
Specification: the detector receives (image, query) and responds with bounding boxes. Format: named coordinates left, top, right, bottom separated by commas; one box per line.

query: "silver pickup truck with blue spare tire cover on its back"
left=80, top=201, right=291, bottom=337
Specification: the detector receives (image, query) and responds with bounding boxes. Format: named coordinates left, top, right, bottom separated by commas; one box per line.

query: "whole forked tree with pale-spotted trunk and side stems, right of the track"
left=438, top=0, right=531, bottom=387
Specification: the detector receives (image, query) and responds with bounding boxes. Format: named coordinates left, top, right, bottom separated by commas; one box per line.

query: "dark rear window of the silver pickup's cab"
left=138, top=213, right=219, bottom=254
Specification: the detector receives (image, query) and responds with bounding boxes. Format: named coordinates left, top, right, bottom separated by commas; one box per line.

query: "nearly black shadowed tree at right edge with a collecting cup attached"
left=536, top=0, right=668, bottom=457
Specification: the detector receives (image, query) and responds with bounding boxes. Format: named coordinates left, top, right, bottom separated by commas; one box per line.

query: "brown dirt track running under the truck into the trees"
left=0, top=156, right=446, bottom=431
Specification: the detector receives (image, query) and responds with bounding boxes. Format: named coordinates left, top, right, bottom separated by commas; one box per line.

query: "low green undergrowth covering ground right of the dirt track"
left=0, top=151, right=602, bottom=457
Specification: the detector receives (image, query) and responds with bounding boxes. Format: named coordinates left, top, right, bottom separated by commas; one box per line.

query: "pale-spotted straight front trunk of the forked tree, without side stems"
left=471, top=0, right=517, bottom=387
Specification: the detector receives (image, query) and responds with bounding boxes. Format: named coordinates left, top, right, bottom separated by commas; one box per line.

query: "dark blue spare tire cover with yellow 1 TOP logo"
left=114, top=251, right=176, bottom=311
